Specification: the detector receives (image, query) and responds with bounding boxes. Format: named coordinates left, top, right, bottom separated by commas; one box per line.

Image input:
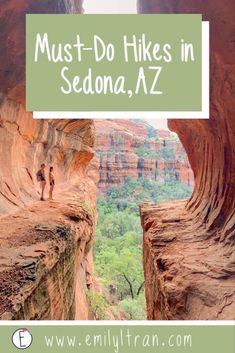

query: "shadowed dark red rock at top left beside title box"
left=0, top=0, right=83, bottom=103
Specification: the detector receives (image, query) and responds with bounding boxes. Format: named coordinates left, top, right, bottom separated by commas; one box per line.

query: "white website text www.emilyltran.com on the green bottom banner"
left=45, top=329, right=193, bottom=353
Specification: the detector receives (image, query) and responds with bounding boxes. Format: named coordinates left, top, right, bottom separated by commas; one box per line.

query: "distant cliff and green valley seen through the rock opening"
left=94, top=119, right=194, bottom=320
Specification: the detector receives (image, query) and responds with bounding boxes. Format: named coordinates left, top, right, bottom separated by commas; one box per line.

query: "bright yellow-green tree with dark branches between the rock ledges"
left=95, top=232, right=143, bottom=300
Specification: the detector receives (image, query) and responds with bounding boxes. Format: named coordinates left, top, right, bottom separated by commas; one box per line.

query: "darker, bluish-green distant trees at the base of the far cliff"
left=98, top=178, right=192, bottom=212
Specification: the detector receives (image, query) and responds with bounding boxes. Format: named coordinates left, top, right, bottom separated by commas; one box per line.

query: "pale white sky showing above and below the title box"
left=83, top=0, right=167, bottom=130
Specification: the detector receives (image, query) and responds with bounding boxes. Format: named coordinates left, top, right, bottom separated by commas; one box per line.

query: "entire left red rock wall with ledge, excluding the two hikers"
left=0, top=0, right=96, bottom=319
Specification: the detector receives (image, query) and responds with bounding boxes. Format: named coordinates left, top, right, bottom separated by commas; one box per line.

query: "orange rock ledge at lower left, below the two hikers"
left=0, top=186, right=96, bottom=320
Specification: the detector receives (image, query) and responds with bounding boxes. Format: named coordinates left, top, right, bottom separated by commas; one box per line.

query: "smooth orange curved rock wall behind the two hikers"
left=0, top=98, right=94, bottom=215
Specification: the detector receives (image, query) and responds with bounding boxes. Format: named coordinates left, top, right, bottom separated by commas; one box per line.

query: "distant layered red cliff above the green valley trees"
left=95, top=120, right=194, bottom=191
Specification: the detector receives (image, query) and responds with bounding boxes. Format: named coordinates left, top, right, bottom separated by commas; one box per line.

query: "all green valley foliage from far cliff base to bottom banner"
left=94, top=178, right=191, bottom=320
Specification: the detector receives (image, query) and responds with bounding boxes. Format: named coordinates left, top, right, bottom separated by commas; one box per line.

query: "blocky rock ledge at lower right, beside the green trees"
left=141, top=201, right=235, bottom=320
